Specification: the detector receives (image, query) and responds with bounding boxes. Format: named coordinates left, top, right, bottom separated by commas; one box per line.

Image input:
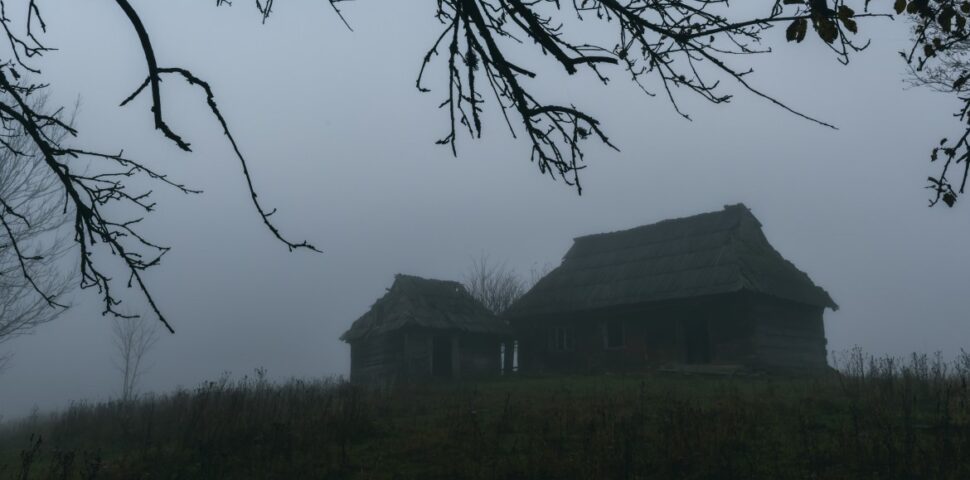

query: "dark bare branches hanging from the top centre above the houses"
left=417, top=0, right=885, bottom=193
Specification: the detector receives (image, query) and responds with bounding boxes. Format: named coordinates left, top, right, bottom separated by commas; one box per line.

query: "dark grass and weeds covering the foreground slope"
left=0, top=351, right=970, bottom=480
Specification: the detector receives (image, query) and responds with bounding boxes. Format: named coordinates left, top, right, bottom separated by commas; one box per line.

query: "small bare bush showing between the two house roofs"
left=465, top=254, right=527, bottom=315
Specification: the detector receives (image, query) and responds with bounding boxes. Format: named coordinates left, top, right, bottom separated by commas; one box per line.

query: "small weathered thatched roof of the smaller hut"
left=340, top=274, right=509, bottom=342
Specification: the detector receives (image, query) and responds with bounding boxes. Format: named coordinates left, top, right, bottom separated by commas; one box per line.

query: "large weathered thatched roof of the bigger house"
left=507, top=204, right=838, bottom=318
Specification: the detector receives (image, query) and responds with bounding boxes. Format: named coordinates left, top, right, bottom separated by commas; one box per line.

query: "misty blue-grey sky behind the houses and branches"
left=0, top=0, right=970, bottom=418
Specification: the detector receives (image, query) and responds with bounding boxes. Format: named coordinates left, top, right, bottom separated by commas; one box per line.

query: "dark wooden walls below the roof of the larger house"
left=519, top=294, right=826, bottom=373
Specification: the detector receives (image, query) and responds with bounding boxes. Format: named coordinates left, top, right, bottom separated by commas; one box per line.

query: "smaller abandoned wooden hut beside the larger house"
left=340, top=274, right=510, bottom=384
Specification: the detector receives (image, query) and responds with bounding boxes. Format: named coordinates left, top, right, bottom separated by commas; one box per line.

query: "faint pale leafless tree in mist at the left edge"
left=0, top=96, right=74, bottom=370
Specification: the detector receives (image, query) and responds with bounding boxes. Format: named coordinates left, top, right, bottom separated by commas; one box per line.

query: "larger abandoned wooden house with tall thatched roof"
left=505, top=204, right=838, bottom=373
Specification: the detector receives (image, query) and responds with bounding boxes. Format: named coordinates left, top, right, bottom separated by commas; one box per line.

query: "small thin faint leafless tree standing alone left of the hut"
left=111, top=317, right=158, bottom=402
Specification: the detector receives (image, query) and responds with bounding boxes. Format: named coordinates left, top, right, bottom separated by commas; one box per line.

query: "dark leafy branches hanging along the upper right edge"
left=894, top=0, right=970, bottom=207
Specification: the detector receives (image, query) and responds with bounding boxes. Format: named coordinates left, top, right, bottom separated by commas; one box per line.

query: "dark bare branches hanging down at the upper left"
left=0, top=0, right=328, bottom=332
